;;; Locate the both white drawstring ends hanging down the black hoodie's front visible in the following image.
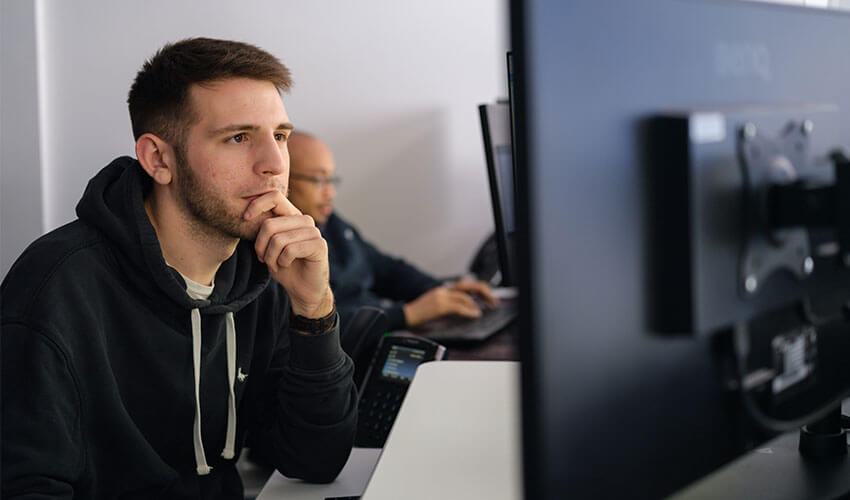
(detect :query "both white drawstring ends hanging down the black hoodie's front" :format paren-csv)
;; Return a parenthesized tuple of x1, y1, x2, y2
(192, 308, 236, 476)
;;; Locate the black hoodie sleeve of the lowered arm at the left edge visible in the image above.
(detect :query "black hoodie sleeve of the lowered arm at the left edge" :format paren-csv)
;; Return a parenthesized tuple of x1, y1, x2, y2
(0, 323, 84, 499)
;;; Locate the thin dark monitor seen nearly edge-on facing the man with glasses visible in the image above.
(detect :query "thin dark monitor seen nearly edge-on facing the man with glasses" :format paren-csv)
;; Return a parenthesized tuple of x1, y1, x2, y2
(478, 102, 516, 286)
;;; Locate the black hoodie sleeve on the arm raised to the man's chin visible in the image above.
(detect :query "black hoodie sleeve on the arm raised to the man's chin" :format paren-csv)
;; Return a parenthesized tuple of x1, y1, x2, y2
(253, 310, 357, 483)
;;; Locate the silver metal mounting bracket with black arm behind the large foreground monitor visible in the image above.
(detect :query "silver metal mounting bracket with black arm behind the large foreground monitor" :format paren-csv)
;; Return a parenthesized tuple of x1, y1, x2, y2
(738, 120, 850, 297)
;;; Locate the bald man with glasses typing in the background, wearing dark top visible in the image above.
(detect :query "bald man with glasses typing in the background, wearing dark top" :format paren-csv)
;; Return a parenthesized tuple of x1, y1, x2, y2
(288, 132, 498, 330)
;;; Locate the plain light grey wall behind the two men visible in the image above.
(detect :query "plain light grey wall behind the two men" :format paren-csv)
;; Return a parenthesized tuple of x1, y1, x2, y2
(0, 0, 508, 275)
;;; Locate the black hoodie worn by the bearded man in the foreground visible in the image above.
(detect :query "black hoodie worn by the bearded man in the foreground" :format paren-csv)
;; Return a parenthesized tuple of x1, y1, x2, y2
(0, 157, 356, 499)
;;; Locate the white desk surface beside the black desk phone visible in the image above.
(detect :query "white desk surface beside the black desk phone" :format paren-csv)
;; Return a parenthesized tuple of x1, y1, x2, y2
(253, 361, 522, 500)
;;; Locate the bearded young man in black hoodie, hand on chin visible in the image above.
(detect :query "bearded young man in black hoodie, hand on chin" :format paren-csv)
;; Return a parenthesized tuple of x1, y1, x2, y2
(0, 38, 356, 499)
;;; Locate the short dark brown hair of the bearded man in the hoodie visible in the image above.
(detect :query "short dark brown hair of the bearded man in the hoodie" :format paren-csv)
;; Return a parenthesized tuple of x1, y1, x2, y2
(127, 38, 292, 148)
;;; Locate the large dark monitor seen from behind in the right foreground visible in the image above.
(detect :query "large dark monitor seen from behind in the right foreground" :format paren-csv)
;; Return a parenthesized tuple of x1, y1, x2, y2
(511, 0, 850, 499)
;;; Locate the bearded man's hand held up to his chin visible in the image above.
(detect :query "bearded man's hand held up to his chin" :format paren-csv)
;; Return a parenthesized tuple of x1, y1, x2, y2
(244, 190, 334, 319)
